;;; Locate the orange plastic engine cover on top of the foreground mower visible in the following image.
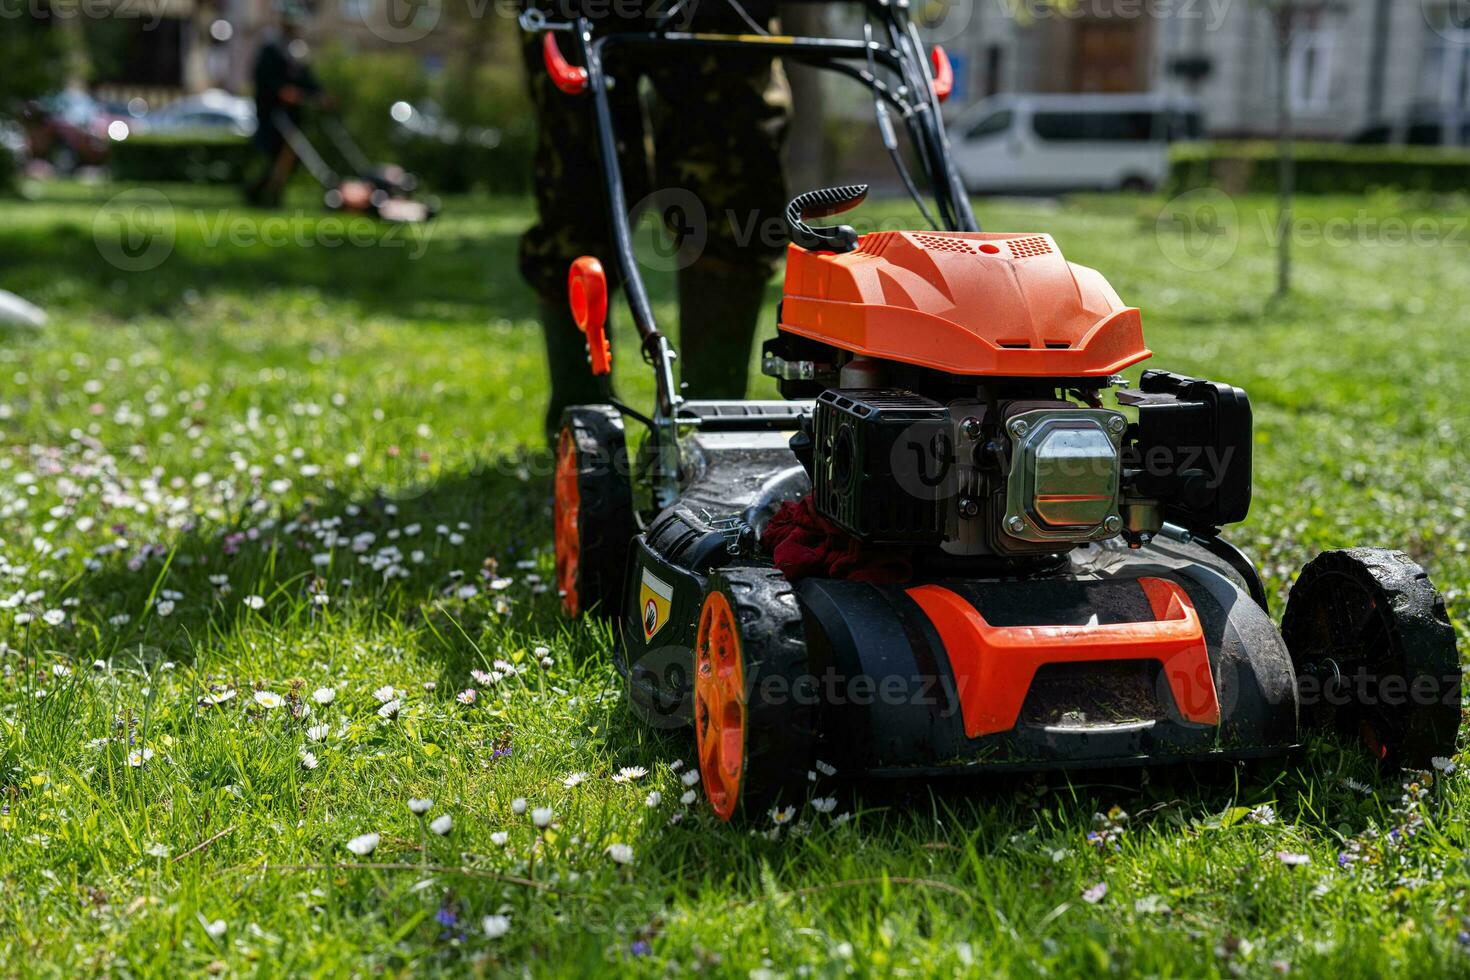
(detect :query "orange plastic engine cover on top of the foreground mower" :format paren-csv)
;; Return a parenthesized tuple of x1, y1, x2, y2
(781, 231, 1151, 378)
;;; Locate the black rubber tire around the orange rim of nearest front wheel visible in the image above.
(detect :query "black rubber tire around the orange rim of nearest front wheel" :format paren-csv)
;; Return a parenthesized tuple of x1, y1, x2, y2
(695, 566, 819, 826)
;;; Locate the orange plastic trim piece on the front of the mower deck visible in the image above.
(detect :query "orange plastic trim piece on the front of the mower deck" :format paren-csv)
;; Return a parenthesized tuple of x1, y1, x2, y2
(908, 579, 1220, 739)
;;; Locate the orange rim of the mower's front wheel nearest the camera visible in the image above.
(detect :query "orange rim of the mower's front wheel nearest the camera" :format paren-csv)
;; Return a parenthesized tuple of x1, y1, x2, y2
(694, 592, 745, 820)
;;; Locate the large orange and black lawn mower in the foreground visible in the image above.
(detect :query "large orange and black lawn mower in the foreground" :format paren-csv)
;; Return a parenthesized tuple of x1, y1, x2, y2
(522, 0, 1461, 820)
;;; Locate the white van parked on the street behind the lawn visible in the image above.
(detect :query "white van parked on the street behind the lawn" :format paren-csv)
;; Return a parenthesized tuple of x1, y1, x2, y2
(948, 94, 1202, 194)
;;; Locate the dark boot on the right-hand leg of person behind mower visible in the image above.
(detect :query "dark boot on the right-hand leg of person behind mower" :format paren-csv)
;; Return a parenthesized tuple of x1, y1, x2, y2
(679, 263, 767, 400)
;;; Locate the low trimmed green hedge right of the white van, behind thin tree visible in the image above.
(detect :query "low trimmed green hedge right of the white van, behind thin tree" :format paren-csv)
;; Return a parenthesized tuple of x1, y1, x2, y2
(1169, 141, 1470, 194)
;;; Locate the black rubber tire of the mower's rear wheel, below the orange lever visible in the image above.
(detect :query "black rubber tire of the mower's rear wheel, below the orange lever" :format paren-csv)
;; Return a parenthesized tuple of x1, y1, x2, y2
(557, 406, 638, 621)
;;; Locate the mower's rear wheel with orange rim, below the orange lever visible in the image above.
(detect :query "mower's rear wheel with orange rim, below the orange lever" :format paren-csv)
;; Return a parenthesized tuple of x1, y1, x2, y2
(554, 406, 637, 620)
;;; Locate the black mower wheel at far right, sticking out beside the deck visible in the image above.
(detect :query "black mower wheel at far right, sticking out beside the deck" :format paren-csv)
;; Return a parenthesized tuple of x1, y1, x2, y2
(1282, 548, 1461, 770)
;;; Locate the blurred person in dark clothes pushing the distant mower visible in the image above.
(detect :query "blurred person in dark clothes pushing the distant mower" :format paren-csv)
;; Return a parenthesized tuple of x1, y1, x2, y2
(245, 4, 322, 207)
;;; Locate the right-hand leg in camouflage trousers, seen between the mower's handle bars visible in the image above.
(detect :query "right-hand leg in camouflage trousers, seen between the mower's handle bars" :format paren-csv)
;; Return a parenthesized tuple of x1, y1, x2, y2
(650, 7, 791, 398)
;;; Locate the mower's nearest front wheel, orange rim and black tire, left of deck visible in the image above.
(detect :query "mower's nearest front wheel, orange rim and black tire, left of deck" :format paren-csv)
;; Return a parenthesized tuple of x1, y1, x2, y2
(694, 567, 817, 820)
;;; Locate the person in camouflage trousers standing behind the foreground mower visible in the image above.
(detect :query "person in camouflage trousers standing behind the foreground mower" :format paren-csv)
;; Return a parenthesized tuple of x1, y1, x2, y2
(520, 0, 791, 444)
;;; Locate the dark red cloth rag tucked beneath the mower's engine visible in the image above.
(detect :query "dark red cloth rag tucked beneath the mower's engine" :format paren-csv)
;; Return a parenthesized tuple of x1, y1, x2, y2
(760, 494, 913, 585)
